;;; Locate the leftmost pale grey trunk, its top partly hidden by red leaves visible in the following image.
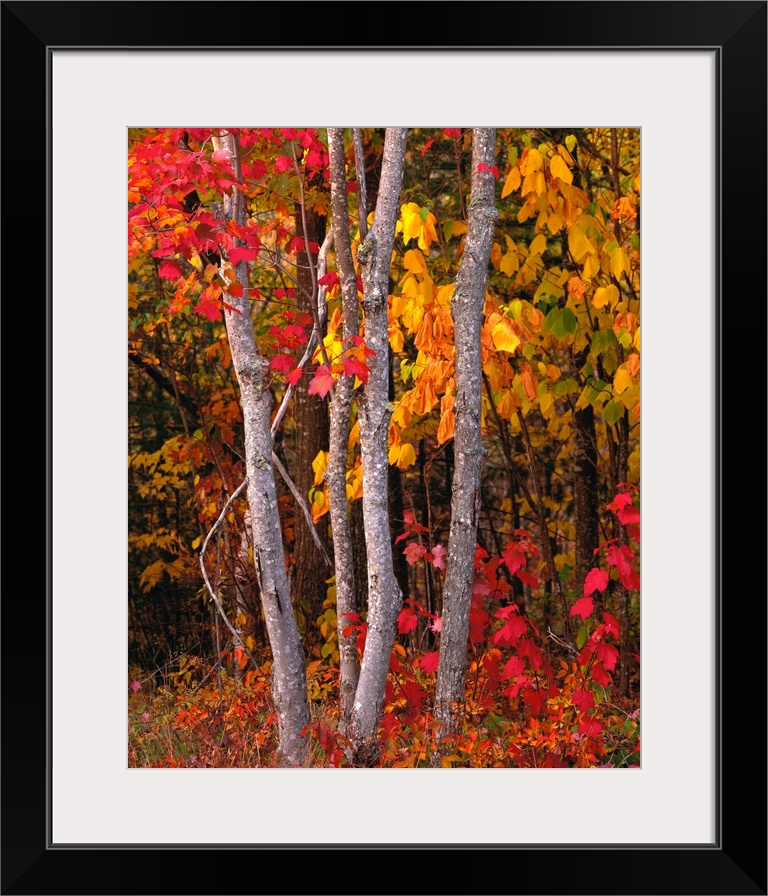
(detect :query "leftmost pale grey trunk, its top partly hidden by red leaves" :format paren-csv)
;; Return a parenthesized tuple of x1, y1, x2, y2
(215, 131, 310, 766)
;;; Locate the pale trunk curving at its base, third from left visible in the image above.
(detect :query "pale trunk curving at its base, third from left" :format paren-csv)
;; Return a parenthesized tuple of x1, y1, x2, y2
(350, 128, 407, 764)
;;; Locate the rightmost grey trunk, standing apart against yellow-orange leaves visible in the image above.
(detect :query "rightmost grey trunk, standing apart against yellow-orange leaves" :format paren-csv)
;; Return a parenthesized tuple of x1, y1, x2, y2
(435, 128, 497, 735)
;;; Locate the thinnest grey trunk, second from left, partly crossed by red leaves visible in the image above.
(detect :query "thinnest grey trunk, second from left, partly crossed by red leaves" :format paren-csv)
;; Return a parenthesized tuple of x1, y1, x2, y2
(326, 128, 360, 734)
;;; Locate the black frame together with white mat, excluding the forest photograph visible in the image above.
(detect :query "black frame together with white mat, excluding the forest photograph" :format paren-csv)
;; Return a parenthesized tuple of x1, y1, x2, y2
(2, 2, 767, 894)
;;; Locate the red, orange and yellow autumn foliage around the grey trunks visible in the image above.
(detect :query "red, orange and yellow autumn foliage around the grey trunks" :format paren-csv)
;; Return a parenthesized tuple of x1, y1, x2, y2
(128, 128, 640, 768)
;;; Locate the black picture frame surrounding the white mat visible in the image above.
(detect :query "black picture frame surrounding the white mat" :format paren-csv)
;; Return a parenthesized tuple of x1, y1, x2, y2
(0, 0, 768, 896)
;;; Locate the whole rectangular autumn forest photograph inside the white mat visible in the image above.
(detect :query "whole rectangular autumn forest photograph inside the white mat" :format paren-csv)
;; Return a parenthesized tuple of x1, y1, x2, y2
(127, 127, 641, 769)
